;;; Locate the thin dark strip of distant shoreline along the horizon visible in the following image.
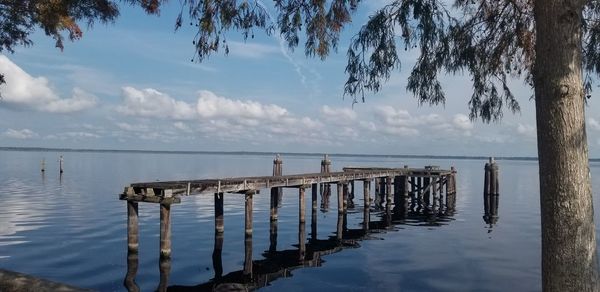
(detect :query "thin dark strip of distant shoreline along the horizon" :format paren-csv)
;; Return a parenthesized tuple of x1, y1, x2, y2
(0, 147, 600, 162)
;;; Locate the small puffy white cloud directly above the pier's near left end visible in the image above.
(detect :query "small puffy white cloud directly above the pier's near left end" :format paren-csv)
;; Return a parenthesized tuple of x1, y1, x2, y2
(117, 86, 195, 120)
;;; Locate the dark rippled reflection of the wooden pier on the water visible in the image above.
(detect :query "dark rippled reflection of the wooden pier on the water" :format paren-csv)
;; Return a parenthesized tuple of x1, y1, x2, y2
(124, 194, 454, 291)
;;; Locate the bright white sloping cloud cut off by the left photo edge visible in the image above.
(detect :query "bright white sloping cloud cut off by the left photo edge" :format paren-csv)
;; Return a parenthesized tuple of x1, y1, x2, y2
(0, 55, 97, 113)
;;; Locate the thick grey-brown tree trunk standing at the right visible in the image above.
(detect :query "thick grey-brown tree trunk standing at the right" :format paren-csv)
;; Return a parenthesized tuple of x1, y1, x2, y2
(534, 0, 599, 291)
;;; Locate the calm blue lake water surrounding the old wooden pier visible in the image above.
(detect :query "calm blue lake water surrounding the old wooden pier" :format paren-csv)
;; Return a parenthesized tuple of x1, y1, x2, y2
(0, 151, 600, 291)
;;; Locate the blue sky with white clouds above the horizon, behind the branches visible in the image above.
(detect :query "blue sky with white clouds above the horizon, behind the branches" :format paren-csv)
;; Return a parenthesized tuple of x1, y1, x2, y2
(0, 1, 600, 157)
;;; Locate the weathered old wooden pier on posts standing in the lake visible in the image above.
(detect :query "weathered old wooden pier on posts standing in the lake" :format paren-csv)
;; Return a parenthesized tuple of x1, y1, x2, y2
(119, 156, 456, 290)
